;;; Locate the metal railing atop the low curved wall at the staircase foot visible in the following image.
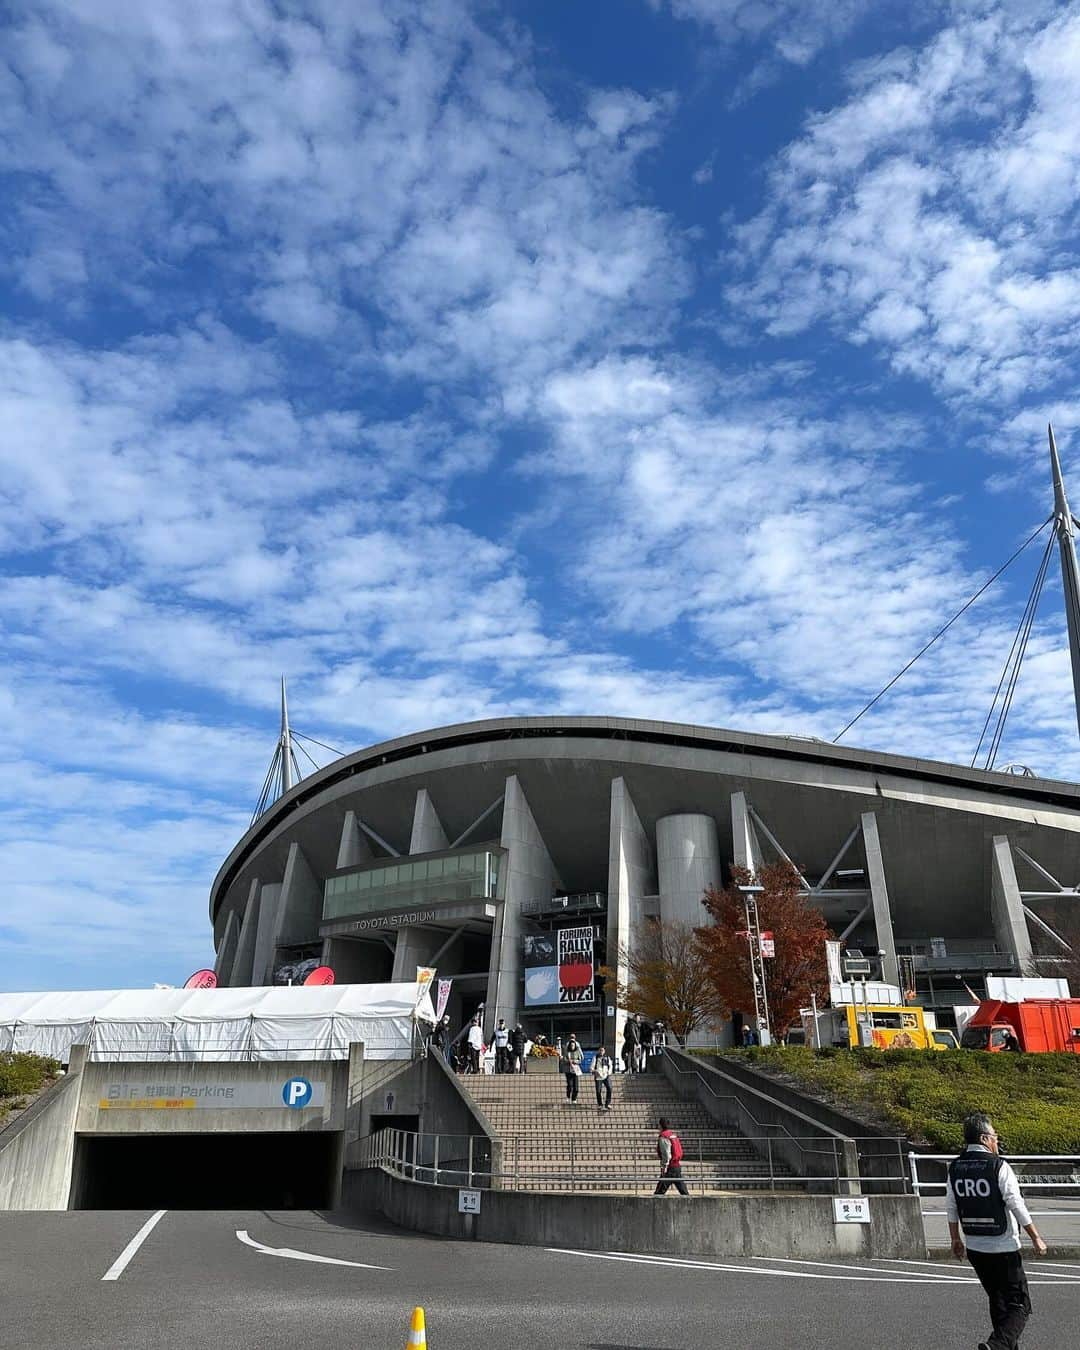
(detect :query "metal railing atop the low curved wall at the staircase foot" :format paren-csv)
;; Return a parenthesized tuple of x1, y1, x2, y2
(356, 1129, 912, 1195)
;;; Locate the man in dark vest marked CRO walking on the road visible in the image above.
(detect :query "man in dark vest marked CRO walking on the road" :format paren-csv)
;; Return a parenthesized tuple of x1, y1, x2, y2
(945, 1112, 1046, 1350)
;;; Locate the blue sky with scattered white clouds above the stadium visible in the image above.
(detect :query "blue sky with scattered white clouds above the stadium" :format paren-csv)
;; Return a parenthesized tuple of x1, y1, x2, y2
(0, 0, 1080, 988)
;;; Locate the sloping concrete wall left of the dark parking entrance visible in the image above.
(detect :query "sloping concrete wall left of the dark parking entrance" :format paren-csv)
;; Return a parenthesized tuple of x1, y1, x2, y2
(0, 1045, 86, 1210)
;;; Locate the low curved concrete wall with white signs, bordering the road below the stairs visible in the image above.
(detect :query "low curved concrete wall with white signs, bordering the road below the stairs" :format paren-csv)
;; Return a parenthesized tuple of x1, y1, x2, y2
(342, 1168, 926, 1260)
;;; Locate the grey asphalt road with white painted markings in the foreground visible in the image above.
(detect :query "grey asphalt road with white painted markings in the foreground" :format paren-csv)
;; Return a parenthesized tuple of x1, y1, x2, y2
(0, 1211, 1080, 1350)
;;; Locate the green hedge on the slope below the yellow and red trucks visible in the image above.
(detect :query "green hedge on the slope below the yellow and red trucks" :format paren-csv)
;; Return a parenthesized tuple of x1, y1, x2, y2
(725, 1045, 1080, 1153)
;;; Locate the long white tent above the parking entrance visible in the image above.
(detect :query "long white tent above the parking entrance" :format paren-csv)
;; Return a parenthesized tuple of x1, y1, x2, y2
(0, 984, 435, 1064)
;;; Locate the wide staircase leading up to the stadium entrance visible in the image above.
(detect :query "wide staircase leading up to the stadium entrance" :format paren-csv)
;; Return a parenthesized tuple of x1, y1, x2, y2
(459, 1073, 792, 1195)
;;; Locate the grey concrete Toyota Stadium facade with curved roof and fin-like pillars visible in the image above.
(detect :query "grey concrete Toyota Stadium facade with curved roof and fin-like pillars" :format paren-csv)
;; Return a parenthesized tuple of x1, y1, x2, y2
(211, 717, 1080, 1045)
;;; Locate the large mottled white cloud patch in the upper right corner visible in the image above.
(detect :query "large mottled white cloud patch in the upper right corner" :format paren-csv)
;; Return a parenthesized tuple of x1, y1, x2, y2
(729, 7, 1080, 406)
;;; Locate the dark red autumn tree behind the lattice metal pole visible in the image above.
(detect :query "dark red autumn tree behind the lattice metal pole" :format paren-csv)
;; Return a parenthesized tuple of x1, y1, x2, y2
(697, 863, 832, 1037)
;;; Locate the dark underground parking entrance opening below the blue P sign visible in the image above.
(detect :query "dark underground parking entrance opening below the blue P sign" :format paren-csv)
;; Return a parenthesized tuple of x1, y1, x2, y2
(72, 1130, 342, 1210)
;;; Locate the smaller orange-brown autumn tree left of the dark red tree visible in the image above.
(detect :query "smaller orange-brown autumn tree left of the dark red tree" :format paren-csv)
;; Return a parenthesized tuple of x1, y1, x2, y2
(599, 919, 720, 1045)
